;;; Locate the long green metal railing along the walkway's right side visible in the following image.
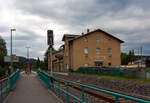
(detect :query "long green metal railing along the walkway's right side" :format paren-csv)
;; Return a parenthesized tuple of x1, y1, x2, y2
(37, 69, 150, 103)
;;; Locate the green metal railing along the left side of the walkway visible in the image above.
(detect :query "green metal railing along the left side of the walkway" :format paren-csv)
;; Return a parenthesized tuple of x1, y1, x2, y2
(0, 69, 20, 103)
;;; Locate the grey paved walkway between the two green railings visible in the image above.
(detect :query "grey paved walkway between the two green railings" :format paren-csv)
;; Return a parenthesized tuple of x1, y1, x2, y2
(6, 73, 60, 103)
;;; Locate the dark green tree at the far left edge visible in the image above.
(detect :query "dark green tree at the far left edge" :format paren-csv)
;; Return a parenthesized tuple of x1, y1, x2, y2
(0, 36, 7, 67)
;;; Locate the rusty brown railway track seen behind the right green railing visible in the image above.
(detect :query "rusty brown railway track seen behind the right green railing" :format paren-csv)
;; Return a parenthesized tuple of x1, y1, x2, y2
(52, 79, 150, 103)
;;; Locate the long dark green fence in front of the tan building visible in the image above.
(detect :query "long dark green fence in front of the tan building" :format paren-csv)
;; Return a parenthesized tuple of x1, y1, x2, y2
(76, 67, 148, 79)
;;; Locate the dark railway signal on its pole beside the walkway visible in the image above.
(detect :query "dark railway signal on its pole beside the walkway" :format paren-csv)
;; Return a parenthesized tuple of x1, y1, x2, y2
(47, 30, 54, 75)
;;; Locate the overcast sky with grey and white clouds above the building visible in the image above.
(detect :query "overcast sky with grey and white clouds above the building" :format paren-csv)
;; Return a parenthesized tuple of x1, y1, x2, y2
(0, 0, 150, 59)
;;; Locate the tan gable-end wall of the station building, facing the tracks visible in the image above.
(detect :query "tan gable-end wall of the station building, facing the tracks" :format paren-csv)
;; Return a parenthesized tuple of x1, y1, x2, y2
(72, 32, 120, 69)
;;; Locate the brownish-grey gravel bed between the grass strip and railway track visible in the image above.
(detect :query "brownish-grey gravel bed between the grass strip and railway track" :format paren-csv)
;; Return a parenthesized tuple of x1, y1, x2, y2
(55, 74, 150, 97)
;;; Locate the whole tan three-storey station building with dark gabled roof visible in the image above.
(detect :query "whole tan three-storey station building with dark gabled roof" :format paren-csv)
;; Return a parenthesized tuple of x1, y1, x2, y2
(48, 29, 123, 70)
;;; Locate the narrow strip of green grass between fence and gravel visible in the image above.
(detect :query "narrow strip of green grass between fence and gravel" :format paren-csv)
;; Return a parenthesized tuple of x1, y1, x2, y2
(73, 72, 150, 83)
